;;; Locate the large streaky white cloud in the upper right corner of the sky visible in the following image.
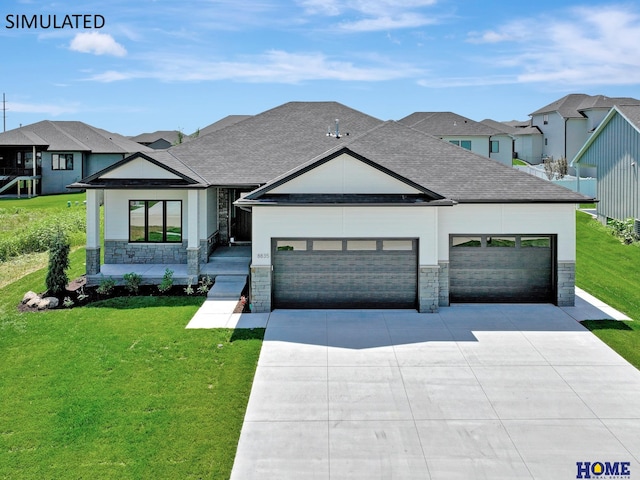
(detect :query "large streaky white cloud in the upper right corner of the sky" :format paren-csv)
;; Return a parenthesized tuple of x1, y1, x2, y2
(419, 5, 640, 88)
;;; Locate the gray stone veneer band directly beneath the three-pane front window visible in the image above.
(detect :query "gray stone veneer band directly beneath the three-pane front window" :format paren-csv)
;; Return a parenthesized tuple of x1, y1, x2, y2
(104, 240, 188, 264)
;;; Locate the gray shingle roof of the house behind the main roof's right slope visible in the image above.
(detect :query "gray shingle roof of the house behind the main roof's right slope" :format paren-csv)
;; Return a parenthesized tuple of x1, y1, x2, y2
(399, 112, 503, 137)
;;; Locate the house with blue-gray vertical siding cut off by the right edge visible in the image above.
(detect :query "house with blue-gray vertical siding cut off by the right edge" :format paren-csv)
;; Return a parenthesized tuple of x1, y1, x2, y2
(572, 105, 640, 223)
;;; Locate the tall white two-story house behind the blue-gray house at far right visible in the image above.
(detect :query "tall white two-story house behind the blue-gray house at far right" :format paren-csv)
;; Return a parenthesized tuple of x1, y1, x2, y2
(529, 93, 640, 169)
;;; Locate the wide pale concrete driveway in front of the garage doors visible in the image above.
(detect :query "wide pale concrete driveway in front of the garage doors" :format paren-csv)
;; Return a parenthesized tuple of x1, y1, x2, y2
(231, 305, 640, 480)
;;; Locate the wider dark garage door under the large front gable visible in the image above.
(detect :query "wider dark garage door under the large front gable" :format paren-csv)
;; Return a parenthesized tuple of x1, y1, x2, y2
(272, 239, 418, 308)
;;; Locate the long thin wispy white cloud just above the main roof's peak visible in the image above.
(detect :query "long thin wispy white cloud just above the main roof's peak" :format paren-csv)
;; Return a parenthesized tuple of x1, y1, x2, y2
(86, 50, 422, 84)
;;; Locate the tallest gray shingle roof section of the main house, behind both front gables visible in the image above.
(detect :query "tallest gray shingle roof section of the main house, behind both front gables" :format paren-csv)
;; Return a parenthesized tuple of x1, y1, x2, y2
(169, 102, 382, 185)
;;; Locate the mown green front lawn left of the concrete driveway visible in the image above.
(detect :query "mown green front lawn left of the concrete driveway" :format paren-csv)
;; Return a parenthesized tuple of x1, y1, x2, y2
(0, 249, 264, 479)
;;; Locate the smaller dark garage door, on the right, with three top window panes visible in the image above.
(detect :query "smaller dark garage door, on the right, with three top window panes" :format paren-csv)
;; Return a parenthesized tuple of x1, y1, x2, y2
(449, 235, 555, 303)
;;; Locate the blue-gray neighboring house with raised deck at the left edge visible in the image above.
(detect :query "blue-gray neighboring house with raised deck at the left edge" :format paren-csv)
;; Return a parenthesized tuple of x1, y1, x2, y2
(0, 120, 152, 195)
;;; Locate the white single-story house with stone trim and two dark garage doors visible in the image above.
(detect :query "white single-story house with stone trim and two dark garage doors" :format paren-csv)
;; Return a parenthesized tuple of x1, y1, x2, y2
(71, 102, 593, 312)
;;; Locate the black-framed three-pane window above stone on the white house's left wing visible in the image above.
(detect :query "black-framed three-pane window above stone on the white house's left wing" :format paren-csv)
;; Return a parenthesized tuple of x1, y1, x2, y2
(129, 200, 182, 243)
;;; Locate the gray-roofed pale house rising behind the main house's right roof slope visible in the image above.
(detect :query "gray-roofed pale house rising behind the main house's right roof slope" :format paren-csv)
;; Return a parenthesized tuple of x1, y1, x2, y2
(399, 112, 513, 166)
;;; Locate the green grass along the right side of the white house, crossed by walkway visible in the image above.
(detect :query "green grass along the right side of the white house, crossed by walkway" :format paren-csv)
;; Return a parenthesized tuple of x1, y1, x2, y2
(576, 212, 640, 368)
